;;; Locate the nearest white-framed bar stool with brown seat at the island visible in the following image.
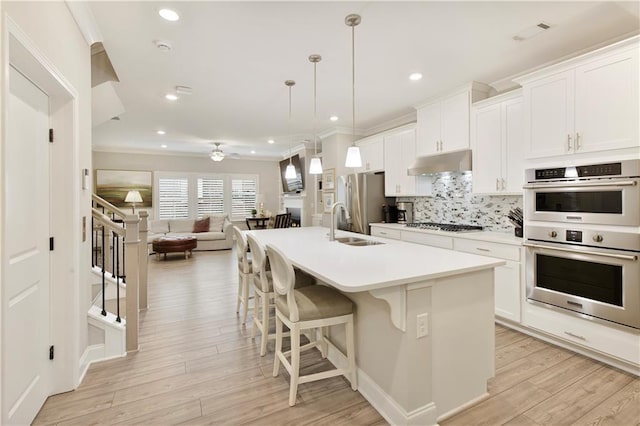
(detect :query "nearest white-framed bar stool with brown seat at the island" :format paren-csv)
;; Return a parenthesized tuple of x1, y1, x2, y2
(266, 244, 358, 407)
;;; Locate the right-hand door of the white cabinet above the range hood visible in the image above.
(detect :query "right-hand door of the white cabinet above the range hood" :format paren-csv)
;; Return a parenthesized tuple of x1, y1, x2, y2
(440, 91, 470, 152)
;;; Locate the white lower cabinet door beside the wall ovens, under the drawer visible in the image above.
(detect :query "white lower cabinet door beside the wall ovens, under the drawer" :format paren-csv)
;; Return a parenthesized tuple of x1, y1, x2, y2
(494, 261, 520, 323)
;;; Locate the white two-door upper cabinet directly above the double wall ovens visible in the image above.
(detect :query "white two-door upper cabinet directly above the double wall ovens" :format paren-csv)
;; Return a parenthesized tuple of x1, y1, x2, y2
(515, 37, 640, 159)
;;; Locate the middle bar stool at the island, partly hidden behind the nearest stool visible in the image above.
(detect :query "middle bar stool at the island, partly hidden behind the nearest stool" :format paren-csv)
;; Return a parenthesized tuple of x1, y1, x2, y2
(247, 234, 316, 356)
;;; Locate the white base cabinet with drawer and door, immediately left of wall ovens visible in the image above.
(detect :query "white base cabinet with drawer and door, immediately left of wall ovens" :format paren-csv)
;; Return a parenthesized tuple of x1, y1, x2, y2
(453, 238, 523, 323)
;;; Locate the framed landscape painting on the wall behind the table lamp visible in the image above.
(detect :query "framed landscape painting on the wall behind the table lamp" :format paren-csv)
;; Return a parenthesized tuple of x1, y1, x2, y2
(95, 170, 153, 207)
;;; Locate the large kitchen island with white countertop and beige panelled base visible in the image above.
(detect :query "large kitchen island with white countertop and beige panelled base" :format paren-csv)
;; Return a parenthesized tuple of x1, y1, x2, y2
(248, 227, 504, 425)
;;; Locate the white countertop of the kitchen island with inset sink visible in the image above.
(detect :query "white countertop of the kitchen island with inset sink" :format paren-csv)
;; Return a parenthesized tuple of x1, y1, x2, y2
(248, 227, 505, 293)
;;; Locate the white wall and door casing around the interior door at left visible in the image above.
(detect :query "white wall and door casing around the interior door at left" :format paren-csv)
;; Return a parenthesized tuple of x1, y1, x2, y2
(0, 0, 91, 402)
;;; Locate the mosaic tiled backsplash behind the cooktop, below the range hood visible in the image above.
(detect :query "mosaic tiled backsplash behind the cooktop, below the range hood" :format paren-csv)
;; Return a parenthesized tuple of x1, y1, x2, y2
(398, 172, 522, 232)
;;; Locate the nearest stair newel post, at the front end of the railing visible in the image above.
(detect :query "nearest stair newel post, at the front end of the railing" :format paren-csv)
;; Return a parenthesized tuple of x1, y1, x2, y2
(124, 215, 141, 352)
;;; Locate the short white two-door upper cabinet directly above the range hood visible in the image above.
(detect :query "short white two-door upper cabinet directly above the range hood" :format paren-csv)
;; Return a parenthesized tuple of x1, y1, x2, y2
(416, 82, 489, 156)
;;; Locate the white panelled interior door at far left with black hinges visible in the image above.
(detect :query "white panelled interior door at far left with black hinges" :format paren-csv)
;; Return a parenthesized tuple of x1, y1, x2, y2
(0, 67, 51, 424)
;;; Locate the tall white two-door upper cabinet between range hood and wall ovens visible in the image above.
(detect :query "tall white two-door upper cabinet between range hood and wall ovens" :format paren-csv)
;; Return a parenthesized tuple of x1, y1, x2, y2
(471, 90, 524, 194)
